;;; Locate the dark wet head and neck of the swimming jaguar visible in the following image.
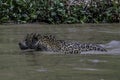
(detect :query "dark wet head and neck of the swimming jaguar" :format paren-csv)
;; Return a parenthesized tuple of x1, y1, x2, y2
(19, 33, 55, 51)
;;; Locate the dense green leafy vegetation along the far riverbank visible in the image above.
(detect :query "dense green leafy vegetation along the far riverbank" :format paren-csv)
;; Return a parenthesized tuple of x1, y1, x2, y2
(0, 0, 120, 24)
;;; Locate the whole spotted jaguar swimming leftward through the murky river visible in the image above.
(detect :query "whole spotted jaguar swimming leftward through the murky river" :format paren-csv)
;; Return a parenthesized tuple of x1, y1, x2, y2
(19, 33, 107, 54)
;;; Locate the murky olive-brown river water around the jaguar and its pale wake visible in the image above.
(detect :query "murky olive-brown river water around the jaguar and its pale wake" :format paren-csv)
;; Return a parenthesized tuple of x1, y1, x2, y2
(0, 24, 120, 80)
